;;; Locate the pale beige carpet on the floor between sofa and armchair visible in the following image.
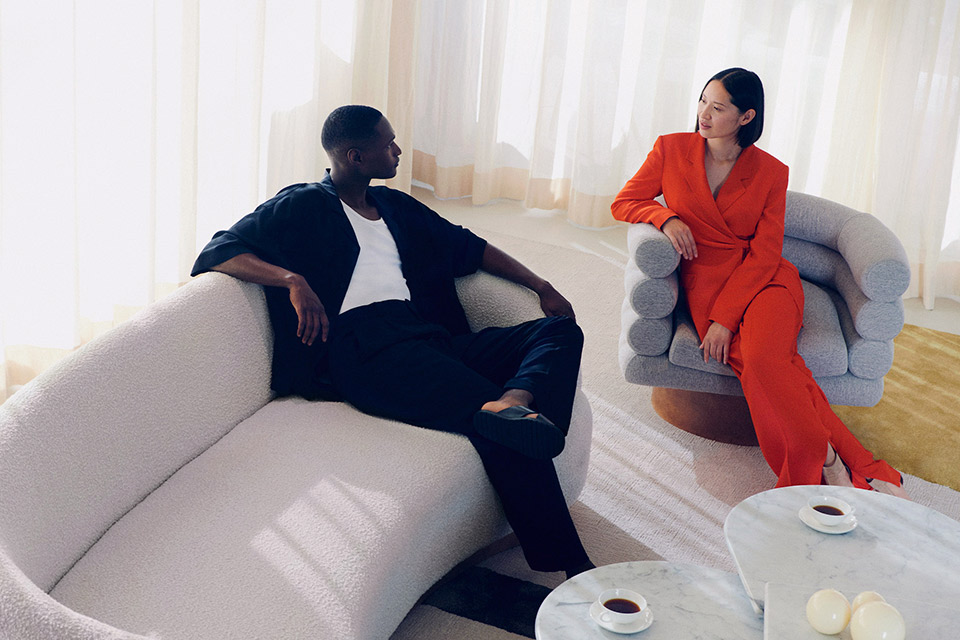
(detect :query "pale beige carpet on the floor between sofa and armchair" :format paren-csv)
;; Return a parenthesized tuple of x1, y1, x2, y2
(393, 232, 960, 640)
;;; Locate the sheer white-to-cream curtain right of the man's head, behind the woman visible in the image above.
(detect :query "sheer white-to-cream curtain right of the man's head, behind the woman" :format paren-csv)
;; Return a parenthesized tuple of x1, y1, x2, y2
(414, 0, 960, 298)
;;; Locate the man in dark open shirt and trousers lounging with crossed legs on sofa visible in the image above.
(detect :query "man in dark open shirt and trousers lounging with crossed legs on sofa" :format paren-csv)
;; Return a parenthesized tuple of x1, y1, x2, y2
(193, 105, 593, 576)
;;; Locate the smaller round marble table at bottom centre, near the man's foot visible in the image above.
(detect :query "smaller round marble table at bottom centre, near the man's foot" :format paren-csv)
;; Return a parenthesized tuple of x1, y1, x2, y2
(534, 562, 763, 640)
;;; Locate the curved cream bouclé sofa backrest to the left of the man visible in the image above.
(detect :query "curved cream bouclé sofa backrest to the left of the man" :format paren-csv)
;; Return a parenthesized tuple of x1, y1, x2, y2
(0, 274, 272, 592)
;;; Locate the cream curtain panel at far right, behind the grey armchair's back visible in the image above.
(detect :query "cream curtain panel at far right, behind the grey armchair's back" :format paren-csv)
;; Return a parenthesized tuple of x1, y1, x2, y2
(824, 0, 960, 309)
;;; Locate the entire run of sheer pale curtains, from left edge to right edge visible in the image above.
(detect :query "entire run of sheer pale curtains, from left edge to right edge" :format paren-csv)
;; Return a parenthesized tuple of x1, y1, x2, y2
(0, 0, 960, 399)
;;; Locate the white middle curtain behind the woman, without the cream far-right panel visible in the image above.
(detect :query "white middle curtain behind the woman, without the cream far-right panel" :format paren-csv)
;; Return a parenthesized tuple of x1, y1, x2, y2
(415, 0, 850, 226)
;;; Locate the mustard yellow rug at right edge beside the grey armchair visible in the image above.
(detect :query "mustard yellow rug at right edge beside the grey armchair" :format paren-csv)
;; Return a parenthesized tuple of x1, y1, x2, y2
(833, 324, 960, 491)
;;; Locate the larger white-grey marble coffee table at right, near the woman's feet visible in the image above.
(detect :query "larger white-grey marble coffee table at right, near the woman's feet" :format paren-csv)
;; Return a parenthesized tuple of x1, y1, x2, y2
(723, 486, 960, 612)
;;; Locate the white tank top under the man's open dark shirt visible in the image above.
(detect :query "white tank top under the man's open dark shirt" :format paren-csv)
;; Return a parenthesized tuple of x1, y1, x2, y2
(340, 200, 410, 313)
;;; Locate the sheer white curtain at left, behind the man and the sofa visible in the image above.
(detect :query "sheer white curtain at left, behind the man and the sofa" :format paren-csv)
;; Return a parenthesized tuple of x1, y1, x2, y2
(0, 0, 416, 400)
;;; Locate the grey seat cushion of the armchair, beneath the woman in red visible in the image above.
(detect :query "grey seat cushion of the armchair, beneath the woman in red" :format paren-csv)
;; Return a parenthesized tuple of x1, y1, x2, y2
(669, 280, 848, 378)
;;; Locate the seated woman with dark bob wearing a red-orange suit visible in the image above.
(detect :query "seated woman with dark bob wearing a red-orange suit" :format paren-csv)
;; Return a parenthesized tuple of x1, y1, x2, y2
(612, 69, 906, 497)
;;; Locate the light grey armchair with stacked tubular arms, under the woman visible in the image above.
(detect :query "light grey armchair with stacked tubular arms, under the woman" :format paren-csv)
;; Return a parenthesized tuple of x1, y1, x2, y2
(620, 191, 910, 440)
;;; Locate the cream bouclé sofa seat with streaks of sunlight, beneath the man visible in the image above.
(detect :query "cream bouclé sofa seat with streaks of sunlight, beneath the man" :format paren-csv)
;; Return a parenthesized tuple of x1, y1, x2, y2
(51, 394, 590, 640)
